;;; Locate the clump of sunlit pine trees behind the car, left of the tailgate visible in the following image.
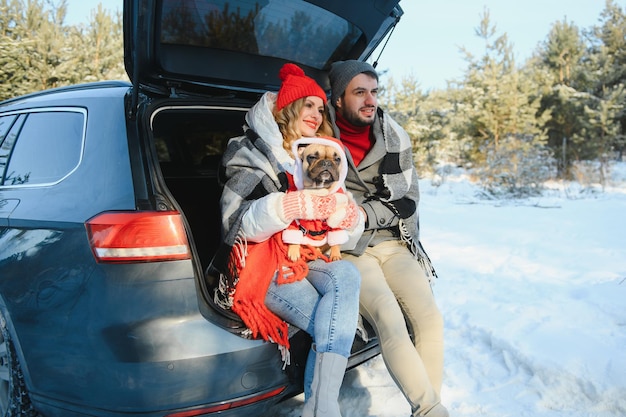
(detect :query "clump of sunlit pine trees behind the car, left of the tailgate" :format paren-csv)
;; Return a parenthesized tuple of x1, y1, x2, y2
(0, 0, 127, 99)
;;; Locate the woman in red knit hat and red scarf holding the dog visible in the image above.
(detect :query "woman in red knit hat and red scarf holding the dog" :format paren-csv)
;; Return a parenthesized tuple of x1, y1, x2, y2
(220, 64, 364, 417)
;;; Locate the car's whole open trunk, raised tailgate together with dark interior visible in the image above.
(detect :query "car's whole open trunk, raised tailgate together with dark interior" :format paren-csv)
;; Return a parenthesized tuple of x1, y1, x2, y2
(130, 0, 402, 386)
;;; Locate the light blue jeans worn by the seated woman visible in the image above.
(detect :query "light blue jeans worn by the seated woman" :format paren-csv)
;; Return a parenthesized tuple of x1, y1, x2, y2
(265, 260, 361, 395)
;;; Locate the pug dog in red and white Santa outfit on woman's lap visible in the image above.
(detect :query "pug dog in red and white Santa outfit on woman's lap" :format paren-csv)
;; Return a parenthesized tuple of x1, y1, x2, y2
(283, 137, 348, 261)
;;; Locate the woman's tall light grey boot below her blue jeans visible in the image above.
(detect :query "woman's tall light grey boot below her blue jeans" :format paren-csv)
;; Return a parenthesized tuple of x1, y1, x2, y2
(302, 352, 348, 417)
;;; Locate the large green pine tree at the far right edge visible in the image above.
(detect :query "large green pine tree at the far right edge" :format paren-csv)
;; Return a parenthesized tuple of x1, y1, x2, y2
(533, 0, 626, 178)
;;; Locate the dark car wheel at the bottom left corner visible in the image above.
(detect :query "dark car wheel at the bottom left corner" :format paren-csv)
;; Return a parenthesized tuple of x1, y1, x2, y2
(0, 313, 40, 417)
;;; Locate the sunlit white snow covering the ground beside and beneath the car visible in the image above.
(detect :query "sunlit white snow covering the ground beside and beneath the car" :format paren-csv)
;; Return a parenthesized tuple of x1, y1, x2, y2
(267, 164, 626, 417)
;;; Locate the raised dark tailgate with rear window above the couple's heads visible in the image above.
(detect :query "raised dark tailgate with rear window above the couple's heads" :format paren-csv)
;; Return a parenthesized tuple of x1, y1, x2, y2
(124, 0, 403, 92)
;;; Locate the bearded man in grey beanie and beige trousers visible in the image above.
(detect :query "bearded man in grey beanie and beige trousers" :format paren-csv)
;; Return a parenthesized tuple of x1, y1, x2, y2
(329, 61, 449, 417)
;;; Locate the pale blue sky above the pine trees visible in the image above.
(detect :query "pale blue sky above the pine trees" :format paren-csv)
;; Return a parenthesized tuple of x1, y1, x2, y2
(66, 0, 608, 90)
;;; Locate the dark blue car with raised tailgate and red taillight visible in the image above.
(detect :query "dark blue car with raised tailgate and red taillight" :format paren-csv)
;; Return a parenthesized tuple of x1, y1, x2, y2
(0, 0, 402, 417)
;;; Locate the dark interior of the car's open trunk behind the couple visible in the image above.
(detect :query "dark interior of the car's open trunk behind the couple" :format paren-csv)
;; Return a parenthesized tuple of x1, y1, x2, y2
(152, 105, 380, 370)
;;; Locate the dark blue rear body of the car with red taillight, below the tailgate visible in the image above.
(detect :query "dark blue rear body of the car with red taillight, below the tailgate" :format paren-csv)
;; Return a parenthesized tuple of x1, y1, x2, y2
(0, 83, 290, 416)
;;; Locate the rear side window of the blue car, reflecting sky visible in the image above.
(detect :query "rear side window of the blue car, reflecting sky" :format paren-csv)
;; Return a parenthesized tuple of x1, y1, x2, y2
(2, 111, 84, 186)
